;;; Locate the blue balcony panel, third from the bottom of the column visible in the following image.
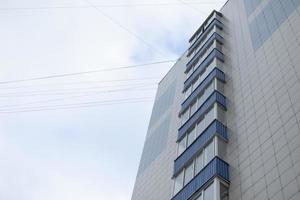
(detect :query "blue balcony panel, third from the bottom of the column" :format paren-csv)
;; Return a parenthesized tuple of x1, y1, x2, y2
(178, 91, 226, 138)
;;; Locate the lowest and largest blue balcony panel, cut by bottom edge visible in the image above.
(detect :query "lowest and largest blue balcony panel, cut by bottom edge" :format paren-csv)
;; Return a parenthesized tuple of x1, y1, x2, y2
(172, 157, 230, 200)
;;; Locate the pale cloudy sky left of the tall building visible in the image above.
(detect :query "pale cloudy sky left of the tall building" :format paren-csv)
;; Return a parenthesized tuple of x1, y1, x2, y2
(0, 0, 225, 200)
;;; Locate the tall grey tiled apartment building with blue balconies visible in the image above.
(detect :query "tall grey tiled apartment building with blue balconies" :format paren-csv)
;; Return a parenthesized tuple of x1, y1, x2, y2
(132, 0, 300, 200)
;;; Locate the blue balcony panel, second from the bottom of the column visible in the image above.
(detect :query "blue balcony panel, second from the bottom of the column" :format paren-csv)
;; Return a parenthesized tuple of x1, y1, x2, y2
(174, 120, 228, 175)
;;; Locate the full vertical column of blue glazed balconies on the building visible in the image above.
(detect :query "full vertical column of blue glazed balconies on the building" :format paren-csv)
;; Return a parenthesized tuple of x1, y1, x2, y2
(172, 11, 229, 200)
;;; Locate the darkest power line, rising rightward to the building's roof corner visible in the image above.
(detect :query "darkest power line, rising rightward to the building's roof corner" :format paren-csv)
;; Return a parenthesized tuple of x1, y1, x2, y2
(0, 60, 176, 85)
